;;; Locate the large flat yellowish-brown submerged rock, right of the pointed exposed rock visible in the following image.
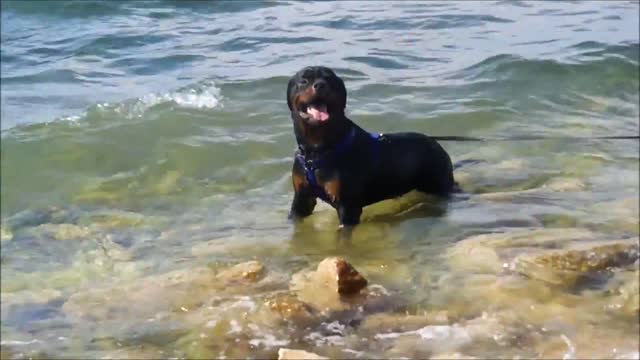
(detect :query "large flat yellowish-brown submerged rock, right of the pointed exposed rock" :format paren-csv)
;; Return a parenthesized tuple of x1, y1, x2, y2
(447, 228, 638, 286)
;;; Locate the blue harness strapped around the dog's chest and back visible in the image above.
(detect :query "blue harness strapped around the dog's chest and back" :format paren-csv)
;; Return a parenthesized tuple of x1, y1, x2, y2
(296, 128, 382, 204)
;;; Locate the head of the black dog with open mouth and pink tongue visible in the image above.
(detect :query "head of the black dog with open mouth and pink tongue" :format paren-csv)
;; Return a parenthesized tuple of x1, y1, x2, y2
(287, 66, 347, 126)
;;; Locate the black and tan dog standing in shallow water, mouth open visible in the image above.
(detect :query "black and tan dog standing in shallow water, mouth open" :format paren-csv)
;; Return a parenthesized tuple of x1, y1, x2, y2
(287, 66, 456, 233)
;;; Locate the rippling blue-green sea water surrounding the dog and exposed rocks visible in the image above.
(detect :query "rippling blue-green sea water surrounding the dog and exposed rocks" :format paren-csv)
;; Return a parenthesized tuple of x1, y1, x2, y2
(0, 0, 640, 358)
